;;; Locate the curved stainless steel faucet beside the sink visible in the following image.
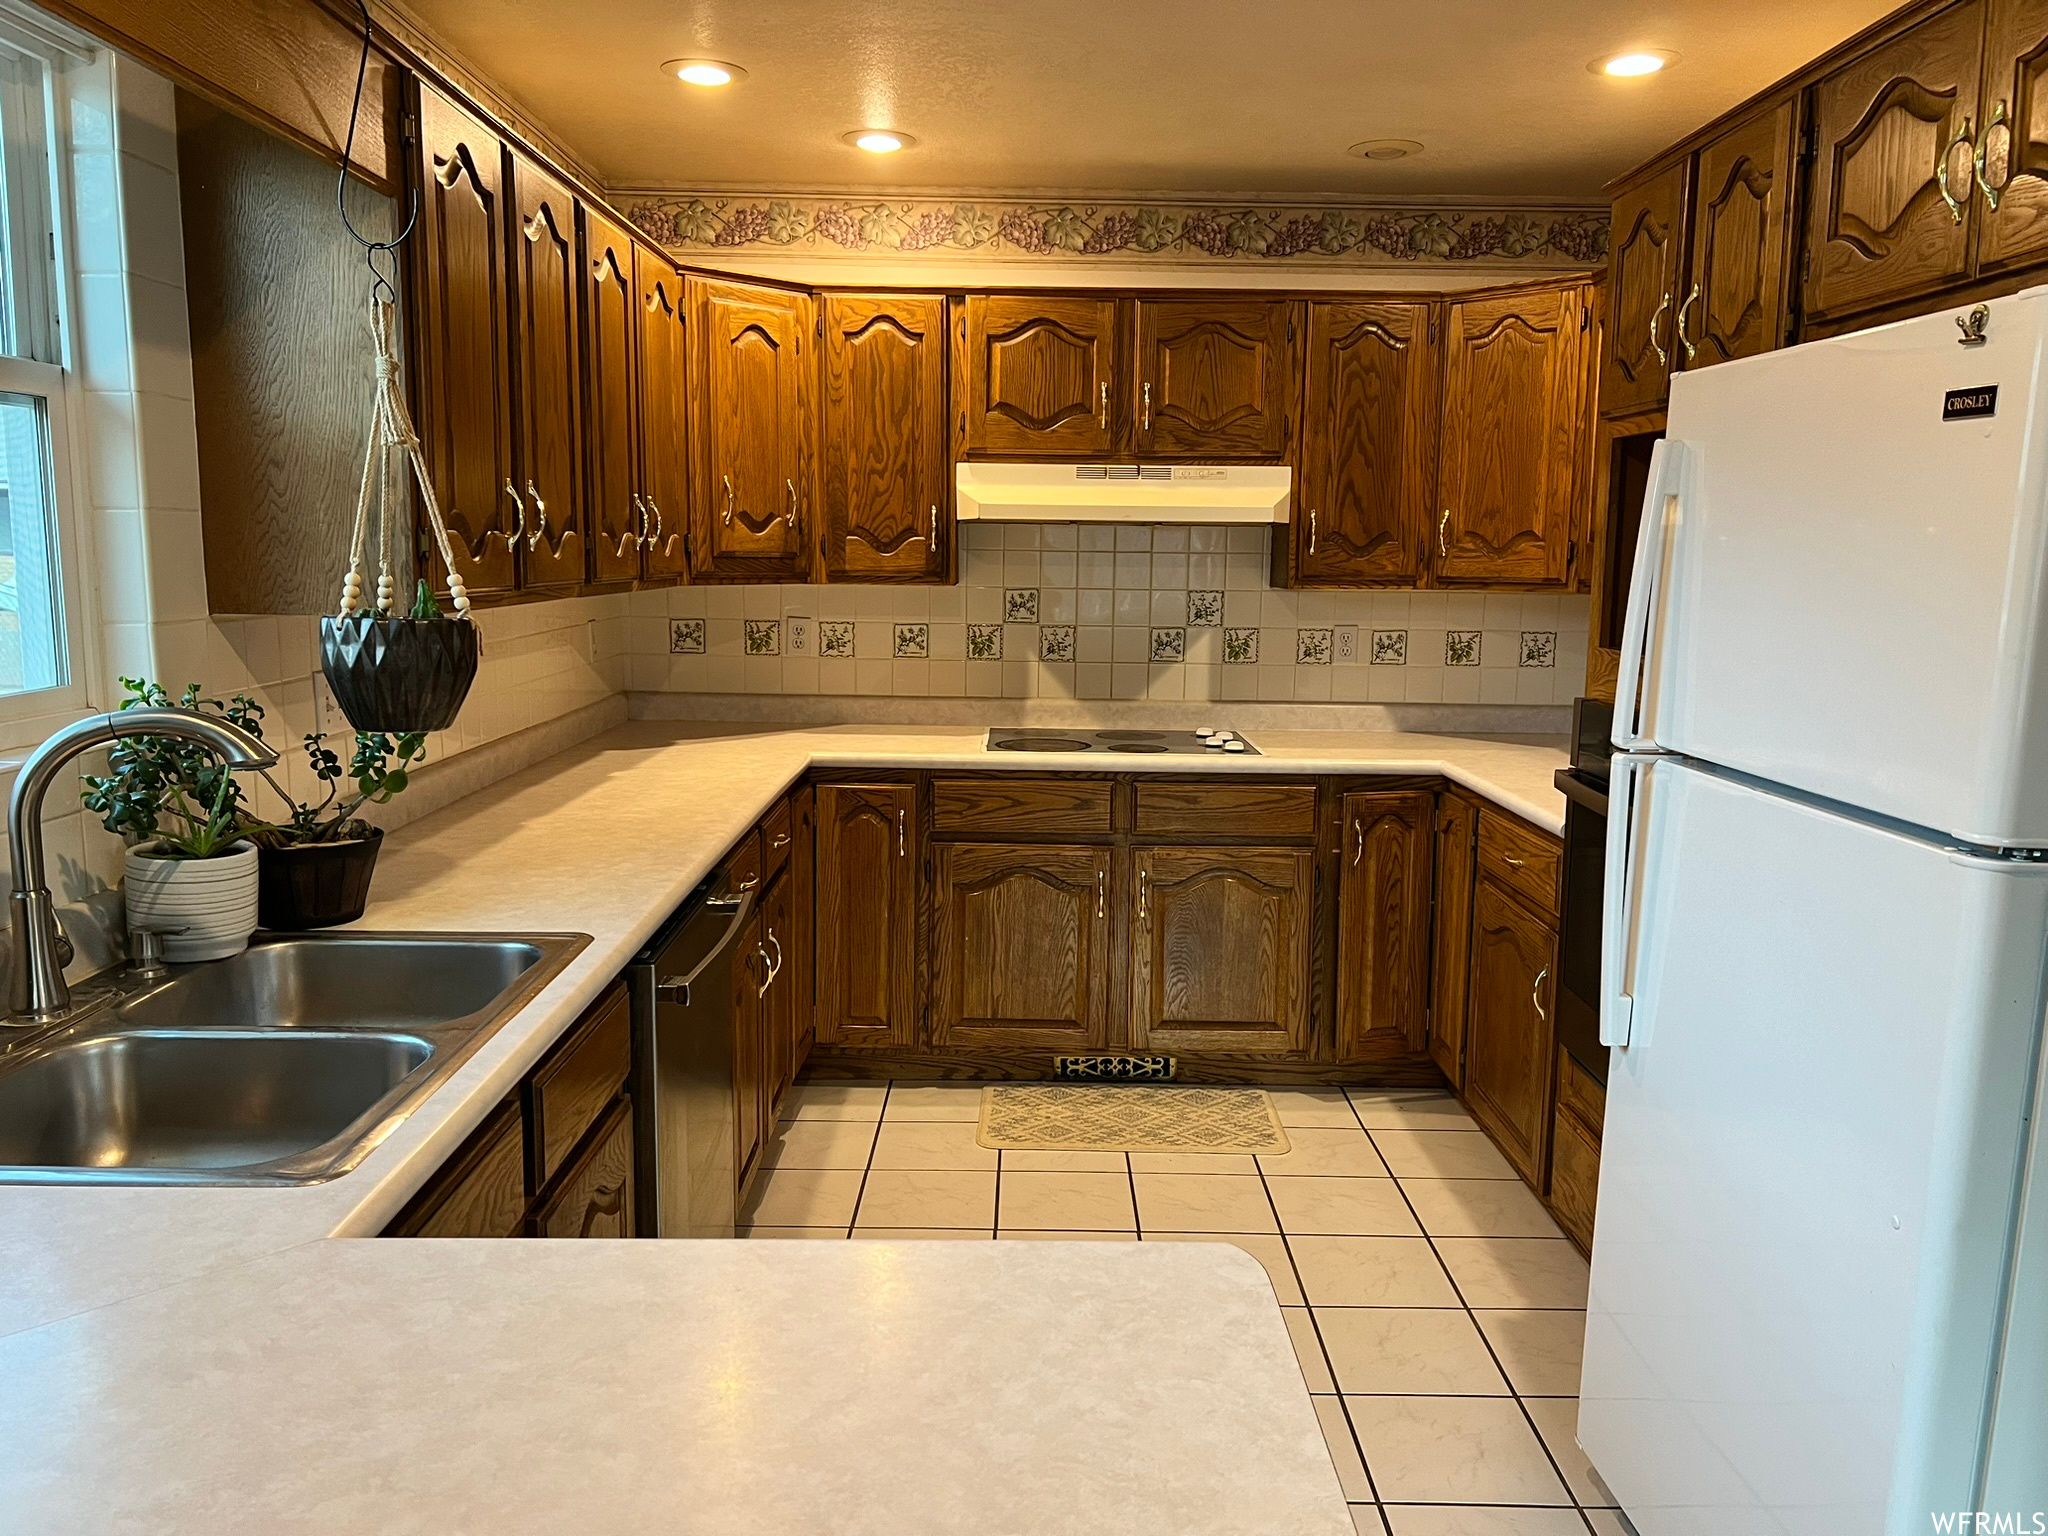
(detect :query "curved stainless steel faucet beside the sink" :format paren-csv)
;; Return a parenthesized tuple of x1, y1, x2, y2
(6, 709, 276, 1026)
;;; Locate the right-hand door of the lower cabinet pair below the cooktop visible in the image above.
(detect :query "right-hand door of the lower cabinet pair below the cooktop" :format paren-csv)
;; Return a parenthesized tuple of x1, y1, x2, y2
(1128, 848, 1315, 1053)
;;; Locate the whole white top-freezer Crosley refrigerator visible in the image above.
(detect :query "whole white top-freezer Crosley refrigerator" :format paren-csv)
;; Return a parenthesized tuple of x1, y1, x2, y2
(1579, 289, 2048, 1536)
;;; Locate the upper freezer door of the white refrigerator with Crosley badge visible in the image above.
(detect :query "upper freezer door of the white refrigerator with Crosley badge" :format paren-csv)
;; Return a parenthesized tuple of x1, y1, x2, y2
(1618, 291, 2048, 846)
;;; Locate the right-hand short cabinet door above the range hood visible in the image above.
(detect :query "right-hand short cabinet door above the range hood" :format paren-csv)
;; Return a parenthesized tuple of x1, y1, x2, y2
(1133, 299, 1300, 459)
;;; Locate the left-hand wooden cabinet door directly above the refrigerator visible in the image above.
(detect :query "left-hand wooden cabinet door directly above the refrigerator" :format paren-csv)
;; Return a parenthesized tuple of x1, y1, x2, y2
(1804, 0, 1985, 317)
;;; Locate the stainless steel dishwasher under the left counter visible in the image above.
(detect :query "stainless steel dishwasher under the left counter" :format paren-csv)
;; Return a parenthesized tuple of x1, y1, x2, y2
(627, 872, 758, 1237)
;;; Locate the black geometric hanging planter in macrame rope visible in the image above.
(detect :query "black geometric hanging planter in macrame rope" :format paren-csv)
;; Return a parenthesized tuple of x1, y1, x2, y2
(319, 612, 483, 735)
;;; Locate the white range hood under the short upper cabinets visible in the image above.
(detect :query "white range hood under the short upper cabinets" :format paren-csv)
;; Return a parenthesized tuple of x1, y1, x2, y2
(954, 463, 1294, 524)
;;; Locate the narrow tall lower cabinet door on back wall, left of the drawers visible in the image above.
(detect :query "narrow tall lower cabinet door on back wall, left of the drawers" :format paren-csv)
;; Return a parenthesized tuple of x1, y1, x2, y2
(817, 784, 918, 1047)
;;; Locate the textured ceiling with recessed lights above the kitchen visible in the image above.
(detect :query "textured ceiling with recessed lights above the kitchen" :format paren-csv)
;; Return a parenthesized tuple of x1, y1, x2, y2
(406, 0, 1892, 199)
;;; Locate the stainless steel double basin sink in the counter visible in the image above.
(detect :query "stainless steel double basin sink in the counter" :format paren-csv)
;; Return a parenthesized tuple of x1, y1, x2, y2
(0, 932, 590, 1184)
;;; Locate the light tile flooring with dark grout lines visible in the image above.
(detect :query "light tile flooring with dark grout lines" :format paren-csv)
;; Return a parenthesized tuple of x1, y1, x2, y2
(741, 1083, 1628, 1536)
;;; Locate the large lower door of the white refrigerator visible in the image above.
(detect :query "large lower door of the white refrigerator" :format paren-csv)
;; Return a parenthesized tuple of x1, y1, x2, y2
(1579, 758, 2048, 1536)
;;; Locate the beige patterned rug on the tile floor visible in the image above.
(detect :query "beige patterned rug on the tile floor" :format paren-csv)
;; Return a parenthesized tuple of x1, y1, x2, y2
(975, 1083, 1288, 1153)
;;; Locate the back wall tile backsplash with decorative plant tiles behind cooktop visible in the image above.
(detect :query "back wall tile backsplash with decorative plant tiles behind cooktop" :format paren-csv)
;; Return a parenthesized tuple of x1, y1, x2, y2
(627, 522, 1587, 707)
